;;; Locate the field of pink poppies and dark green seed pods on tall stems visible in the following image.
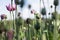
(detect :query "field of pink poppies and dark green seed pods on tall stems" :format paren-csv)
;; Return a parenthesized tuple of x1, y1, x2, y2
(0, 0, 60, 40)
